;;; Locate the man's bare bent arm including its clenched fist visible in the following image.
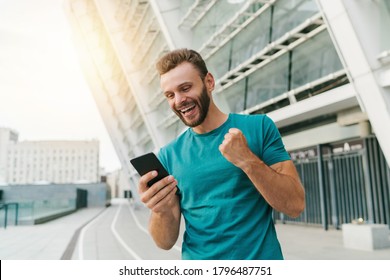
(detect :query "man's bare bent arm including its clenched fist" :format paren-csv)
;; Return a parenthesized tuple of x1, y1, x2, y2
(219, 128, 305, 218)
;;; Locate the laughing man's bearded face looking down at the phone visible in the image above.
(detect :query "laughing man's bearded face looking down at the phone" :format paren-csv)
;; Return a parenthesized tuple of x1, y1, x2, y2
(161, 62, 210, 127)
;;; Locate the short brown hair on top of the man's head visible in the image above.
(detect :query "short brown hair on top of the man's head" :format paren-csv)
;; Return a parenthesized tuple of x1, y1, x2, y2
(156, 48, 208, 80)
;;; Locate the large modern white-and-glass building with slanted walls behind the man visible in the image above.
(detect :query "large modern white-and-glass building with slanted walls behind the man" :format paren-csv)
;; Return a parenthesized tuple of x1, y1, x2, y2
(65, 0, 390, 228)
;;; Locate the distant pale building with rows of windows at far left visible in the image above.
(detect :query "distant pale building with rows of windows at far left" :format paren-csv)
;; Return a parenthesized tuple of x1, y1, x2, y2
(0, 128, 100, 185)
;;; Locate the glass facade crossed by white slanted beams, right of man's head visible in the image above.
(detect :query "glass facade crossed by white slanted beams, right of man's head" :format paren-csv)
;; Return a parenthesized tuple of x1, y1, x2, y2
(200, 0, 343, 112)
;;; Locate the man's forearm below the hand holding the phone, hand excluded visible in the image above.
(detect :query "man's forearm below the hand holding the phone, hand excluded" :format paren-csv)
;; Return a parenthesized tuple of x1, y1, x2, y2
(149, 197, 180, 250)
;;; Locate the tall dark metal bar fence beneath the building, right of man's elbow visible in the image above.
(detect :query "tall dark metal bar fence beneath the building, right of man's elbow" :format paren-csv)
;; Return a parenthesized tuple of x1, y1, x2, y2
(275, 137, 390, 230)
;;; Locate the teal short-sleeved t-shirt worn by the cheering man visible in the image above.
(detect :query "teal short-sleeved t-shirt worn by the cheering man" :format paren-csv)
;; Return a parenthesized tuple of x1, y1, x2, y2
(158, 114, 290, 260)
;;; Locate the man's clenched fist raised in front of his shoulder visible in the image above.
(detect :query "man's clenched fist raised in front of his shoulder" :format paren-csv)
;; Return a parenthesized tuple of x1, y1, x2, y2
(219, 128, 254, 168)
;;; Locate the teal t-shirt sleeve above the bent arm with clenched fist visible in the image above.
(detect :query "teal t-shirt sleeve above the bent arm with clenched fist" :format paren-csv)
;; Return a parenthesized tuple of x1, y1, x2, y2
(262, 116, 290, 166)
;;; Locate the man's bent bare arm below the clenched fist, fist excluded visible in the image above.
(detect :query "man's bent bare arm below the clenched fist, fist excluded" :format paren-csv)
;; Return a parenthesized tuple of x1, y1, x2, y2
(240, 155, 305, 217)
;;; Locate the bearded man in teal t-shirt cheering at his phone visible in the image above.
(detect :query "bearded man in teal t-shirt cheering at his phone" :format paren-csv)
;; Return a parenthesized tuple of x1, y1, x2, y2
(139, 49, 305, 259)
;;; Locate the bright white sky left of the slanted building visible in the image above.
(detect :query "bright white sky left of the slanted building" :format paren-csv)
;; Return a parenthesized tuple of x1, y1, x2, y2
(0, 0, 120, 172)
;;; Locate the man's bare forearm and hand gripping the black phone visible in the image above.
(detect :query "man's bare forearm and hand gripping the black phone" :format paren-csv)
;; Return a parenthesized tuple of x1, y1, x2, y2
(138, 171, 181, 250)
